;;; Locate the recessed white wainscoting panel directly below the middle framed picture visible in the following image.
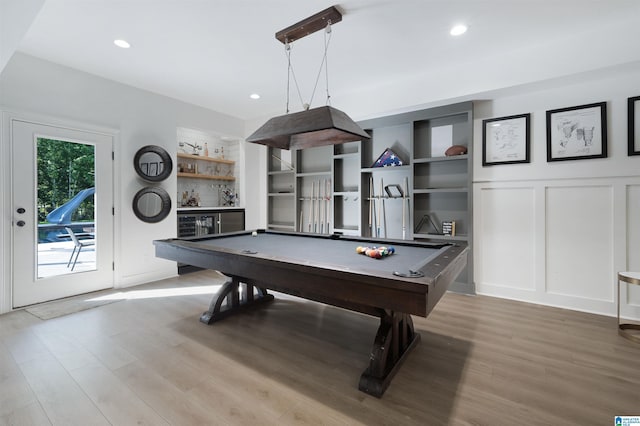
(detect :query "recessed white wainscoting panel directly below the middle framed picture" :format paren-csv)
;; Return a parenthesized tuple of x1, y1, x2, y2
(546, 185, 614, 301)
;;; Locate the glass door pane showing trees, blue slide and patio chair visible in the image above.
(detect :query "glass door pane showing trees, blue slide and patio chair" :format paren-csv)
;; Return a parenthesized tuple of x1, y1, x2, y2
(37, 138, 96, 278)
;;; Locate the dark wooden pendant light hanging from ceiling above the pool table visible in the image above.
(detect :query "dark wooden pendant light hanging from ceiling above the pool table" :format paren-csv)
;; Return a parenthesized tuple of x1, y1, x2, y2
(246, 6, 370, 149)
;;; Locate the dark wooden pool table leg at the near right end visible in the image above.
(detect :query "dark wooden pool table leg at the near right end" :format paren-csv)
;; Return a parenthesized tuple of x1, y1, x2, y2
(358, 310, 420, 398)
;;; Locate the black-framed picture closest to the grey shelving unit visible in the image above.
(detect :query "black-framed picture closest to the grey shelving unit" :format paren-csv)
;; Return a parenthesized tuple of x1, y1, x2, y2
(482, 114, 531, 166)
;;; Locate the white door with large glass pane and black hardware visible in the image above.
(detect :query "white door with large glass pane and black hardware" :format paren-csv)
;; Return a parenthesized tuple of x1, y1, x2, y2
(11, 120, 113, 308)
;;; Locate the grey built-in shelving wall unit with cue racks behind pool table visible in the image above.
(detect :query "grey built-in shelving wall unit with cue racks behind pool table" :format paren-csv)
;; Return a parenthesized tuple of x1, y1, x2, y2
(267, 102, 475, 293)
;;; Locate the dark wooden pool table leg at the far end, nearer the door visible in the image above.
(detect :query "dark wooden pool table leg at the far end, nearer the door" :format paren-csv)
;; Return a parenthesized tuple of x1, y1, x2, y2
(200, 277, 273, 324)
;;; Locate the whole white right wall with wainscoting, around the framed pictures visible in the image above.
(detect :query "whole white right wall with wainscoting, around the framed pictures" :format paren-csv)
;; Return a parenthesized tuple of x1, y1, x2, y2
(473, 60, 640, 318)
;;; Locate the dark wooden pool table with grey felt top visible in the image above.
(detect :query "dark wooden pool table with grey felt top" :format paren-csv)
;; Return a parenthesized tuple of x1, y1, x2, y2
(153, 230, 467, 397)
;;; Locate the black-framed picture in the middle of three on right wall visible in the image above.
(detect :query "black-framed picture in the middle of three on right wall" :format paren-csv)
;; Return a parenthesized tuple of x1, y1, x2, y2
(547, 102, 607, 161)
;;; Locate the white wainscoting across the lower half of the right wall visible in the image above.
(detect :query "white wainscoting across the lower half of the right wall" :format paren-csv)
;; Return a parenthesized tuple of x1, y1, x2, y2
(473, 177, 640, 321)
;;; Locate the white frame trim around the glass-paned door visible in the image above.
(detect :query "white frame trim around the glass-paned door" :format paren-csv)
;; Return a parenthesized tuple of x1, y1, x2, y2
(0, 110, 121, 314)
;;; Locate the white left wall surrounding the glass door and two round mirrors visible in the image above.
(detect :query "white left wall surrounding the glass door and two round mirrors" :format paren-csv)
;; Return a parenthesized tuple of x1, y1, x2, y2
(0, 54, 251, 312)
